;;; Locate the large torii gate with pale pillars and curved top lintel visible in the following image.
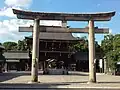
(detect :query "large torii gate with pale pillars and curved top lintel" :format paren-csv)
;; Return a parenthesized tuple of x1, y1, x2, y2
(13, 9, 115, 83)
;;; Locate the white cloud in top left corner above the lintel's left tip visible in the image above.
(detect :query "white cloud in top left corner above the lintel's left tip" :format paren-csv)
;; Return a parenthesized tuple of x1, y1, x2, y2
(0, 0, 32, 17)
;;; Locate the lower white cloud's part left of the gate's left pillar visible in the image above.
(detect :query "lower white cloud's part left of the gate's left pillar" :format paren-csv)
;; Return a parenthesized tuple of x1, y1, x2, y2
(0, 19, 32, 41)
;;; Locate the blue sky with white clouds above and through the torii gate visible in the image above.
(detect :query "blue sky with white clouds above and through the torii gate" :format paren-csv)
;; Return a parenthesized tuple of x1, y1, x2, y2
(0, 0, 120, 43)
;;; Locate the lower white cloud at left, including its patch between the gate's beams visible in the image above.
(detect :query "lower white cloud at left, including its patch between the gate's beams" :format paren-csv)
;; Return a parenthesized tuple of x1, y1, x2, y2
(0, 19, 61, 42)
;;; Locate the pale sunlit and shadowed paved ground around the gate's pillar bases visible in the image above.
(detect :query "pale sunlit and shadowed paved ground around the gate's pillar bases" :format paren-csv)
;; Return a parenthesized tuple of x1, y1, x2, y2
(0, 72, 120, 90)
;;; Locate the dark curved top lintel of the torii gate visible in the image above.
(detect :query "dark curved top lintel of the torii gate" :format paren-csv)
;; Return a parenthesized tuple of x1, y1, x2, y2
(13, 9, 115, 21)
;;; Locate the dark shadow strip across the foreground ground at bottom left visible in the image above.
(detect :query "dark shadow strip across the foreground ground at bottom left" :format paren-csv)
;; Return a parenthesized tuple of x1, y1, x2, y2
(0, 83, 70, 90)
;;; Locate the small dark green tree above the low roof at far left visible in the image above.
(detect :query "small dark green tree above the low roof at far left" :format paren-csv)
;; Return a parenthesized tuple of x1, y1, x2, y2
(3, 42, 17, 50)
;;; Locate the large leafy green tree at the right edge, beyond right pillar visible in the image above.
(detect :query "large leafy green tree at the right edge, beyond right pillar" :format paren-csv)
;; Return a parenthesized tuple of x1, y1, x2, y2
(101, 34, 120, 72)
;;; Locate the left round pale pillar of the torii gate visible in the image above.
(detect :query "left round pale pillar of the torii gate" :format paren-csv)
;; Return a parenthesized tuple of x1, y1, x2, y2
(31, 19, 39, 82)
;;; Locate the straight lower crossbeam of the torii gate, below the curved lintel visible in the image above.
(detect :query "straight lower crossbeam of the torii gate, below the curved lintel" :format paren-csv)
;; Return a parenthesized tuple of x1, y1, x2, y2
(19, 26, 109, 34)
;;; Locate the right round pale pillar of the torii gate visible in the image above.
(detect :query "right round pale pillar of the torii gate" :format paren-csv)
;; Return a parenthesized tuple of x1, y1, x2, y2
(89, 20, 96, 83)
